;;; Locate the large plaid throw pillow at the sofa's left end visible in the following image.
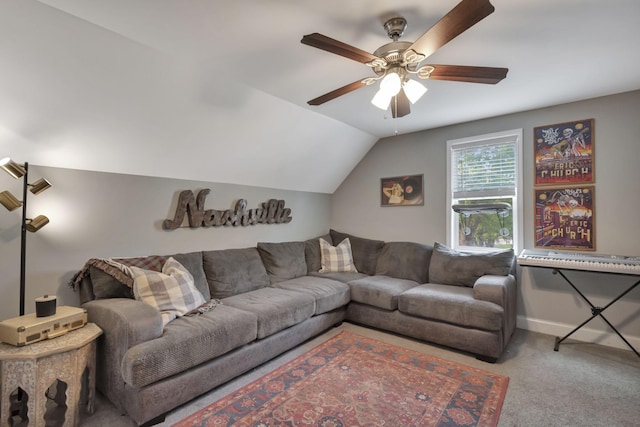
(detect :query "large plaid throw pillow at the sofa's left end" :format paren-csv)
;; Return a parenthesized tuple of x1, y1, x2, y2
(129, 258, 205, 326)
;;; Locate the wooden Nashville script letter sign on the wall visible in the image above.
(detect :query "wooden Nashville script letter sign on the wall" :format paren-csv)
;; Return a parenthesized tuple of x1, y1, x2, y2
(162, 188, 293, 230)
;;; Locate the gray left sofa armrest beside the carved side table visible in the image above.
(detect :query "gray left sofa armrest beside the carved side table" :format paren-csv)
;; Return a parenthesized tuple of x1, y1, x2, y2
(82, 298, 163, 409)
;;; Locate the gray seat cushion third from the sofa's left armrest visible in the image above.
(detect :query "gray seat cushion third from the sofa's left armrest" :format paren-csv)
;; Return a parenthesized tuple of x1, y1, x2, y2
(272, 276, 350, 314)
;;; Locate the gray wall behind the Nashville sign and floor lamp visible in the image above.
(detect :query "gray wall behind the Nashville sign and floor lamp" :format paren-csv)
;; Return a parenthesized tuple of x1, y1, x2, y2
(0, 169, 330, 319)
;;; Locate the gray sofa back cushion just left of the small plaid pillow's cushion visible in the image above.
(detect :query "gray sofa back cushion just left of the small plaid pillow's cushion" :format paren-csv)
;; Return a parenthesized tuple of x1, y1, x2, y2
(257, 242, 307, 284)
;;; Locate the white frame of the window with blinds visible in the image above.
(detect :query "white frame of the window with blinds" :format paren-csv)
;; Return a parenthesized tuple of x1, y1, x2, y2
(446, 128, 524, 253)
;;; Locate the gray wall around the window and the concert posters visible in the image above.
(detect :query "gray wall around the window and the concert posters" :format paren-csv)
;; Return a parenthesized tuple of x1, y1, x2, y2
(331, 91, 640, 349)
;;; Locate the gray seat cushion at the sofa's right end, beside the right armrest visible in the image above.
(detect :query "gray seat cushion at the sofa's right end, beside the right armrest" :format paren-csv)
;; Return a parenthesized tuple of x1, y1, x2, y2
(400, 283, 504, 331)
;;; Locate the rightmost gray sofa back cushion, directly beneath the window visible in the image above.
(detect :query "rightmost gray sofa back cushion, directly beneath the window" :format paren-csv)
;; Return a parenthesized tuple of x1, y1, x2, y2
(429, 242, 514, 287)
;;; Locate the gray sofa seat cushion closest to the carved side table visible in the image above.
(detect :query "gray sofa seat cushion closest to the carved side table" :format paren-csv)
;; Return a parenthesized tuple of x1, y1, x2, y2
(120, 305, 258, 388)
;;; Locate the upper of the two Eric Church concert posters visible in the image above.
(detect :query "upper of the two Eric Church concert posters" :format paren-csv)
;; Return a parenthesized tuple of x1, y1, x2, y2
(533, 119, 595, 185)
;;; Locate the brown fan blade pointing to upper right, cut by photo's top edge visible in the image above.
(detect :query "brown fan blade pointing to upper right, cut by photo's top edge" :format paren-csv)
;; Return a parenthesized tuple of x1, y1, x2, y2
(409, 0, 495, 57)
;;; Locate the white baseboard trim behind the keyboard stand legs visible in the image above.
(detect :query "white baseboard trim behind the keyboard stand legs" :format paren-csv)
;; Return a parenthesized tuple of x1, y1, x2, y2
(516, 316, 640, 351)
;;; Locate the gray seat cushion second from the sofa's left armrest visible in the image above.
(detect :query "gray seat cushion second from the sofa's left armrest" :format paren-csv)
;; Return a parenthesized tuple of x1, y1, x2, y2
(222, 287, 316, 339)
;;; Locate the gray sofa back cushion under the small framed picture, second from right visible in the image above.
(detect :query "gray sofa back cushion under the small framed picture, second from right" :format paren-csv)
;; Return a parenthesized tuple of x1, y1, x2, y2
(376, 242, 433, 283)
